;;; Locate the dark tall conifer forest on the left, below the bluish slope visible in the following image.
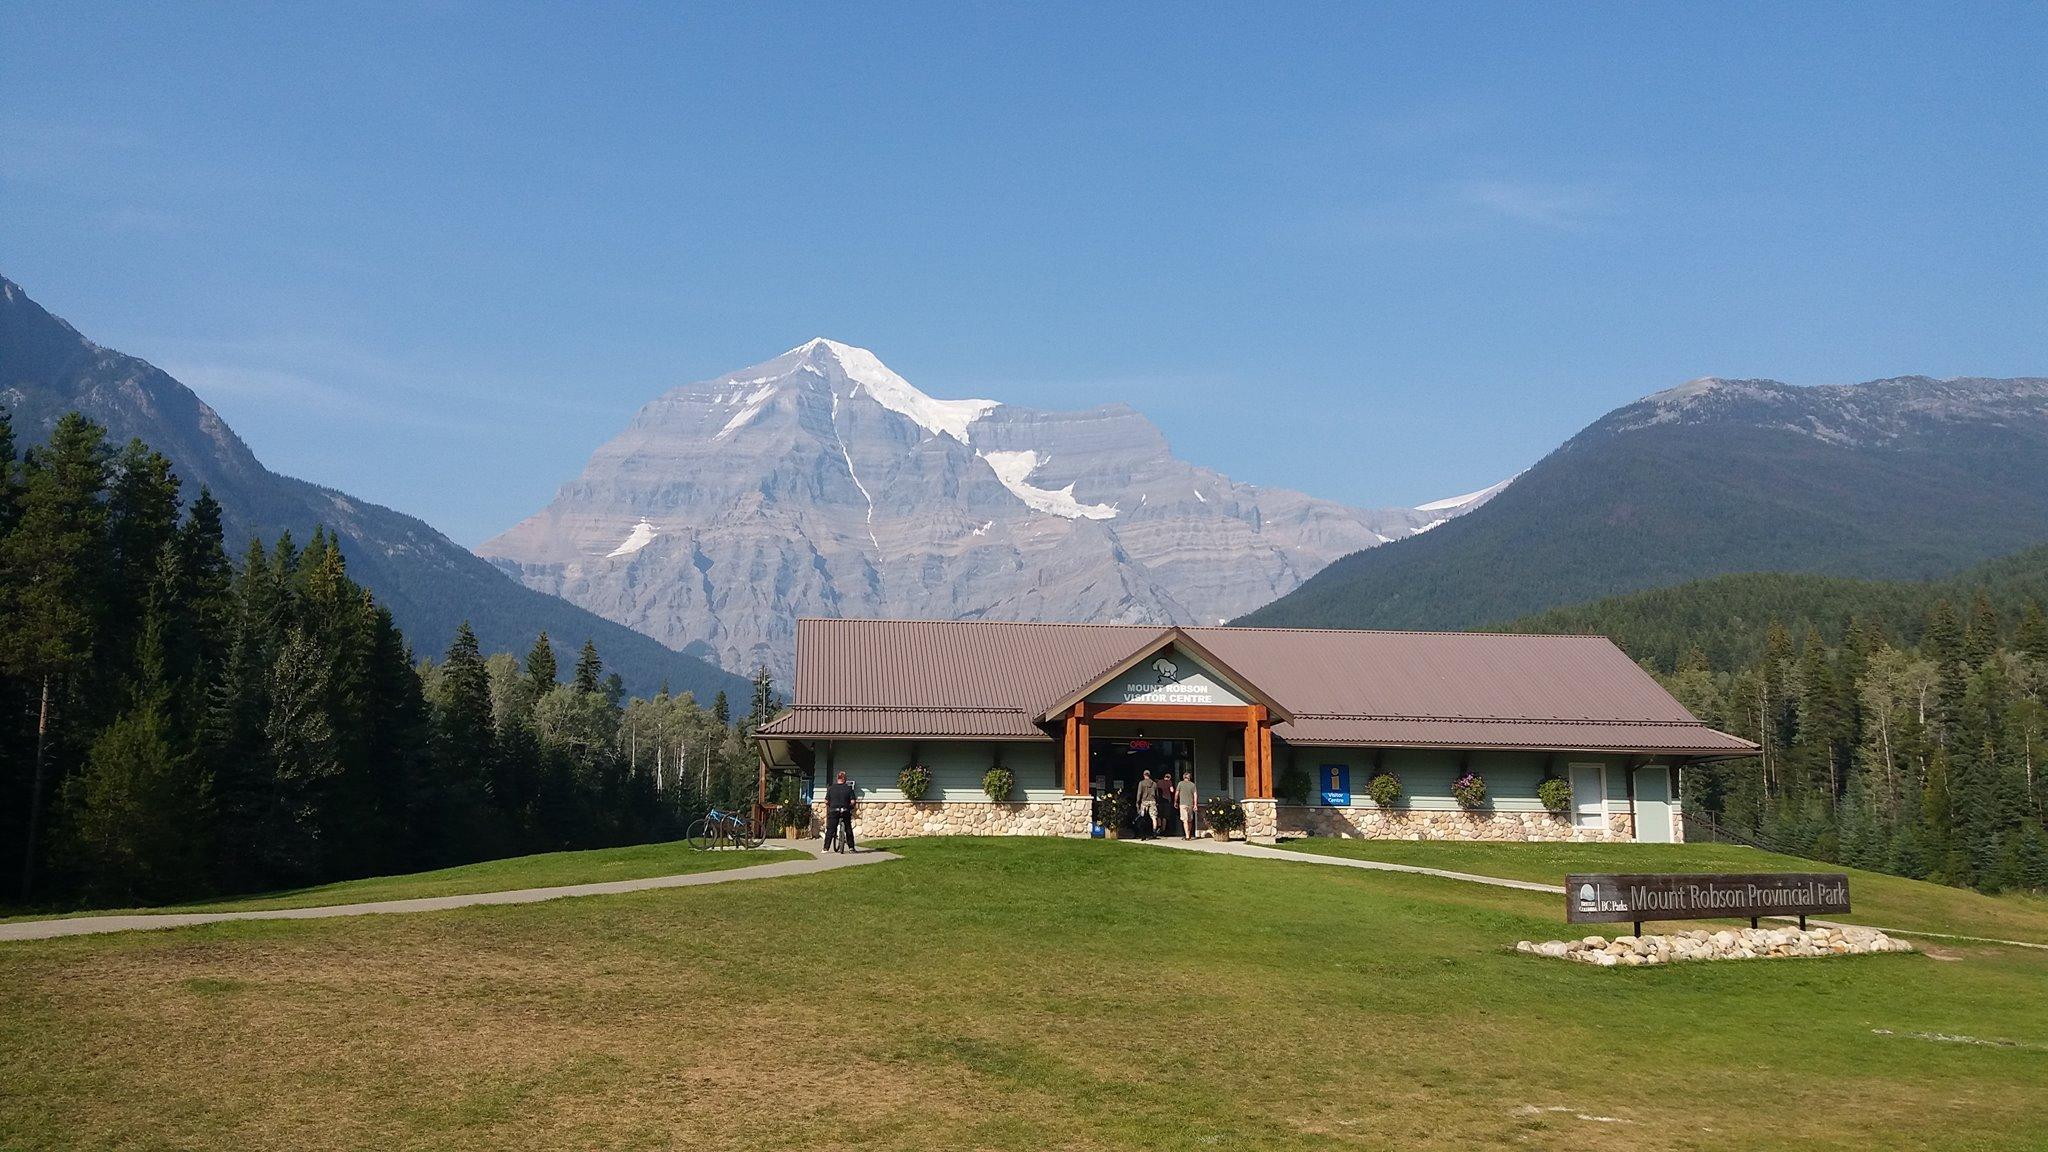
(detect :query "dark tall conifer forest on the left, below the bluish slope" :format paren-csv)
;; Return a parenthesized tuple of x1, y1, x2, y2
(0, 412, 774, 906)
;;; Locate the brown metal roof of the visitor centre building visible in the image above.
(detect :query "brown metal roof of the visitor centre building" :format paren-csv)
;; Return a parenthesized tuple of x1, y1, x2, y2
(764, 619, 1751, 754)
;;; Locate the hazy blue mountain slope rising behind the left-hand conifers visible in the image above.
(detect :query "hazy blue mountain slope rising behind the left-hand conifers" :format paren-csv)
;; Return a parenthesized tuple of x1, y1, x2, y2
(0, 277, 748, 701)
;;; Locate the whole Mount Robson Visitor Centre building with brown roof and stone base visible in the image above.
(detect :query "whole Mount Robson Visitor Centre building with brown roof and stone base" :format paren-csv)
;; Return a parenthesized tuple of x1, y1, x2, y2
(756, 619, 1755, 842)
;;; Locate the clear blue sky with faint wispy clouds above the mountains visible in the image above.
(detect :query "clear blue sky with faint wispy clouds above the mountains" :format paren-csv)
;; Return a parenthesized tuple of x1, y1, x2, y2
(0, 0, 2048, 543)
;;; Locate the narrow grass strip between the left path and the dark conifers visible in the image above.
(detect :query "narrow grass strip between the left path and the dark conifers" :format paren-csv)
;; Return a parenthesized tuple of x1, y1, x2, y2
(8, 828, 807, 920)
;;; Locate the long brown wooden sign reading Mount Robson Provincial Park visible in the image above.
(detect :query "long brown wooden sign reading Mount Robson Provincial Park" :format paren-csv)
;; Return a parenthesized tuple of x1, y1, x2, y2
(1565, 871, 1849, 935)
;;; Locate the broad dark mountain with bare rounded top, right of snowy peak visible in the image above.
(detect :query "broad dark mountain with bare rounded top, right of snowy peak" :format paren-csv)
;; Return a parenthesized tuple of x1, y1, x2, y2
(1241, 377, 2048, 627)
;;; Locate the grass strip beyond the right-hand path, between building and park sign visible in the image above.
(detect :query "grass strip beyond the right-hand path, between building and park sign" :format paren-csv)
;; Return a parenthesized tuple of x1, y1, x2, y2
(1280, 836, 2048, 945)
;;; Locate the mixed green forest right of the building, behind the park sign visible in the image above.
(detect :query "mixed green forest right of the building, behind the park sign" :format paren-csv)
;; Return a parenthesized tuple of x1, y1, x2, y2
(1613, 580, 2048, 892)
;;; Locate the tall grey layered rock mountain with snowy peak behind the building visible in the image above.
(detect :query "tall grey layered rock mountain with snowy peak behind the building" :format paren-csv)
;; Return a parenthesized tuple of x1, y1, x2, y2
(479, 340, 1499, 678)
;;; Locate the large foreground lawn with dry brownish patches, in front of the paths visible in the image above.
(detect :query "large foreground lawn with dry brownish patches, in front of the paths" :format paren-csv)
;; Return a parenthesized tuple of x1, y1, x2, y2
(0, 838, 2048, 1152)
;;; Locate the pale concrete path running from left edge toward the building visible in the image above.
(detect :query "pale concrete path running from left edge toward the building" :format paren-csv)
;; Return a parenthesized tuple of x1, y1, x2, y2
(0, 840, 901, 941)
